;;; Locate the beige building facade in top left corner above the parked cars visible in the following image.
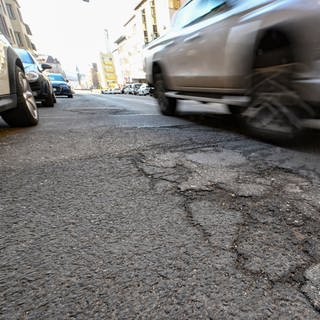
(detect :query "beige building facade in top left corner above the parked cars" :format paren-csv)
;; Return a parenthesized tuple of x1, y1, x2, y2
(0, 0, 36, 55)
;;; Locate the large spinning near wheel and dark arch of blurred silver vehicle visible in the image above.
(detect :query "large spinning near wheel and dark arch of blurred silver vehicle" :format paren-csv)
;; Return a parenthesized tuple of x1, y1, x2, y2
(242, 47, 312, 142)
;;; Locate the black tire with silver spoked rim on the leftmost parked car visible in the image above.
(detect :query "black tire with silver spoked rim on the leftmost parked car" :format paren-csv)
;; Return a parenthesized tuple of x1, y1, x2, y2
(1, 65, 39, 127)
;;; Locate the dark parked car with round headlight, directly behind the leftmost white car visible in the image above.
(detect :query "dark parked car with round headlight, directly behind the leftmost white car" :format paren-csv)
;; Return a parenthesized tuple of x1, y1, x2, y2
(15, 49, 56, 107)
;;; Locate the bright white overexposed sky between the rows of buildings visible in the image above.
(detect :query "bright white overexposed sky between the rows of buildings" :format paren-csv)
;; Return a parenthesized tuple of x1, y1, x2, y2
(18, 0, 138, 74)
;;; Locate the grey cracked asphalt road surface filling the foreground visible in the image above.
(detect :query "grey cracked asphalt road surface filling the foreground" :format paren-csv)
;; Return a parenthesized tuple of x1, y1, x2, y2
(0, 93, 320, 319)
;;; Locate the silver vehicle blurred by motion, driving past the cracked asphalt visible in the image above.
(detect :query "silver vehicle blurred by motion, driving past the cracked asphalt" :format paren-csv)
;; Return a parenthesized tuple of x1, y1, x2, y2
(144, 0, 320, 139)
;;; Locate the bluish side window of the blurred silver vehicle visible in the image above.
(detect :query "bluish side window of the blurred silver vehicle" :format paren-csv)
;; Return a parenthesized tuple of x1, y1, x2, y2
(173, 0, 227, 29)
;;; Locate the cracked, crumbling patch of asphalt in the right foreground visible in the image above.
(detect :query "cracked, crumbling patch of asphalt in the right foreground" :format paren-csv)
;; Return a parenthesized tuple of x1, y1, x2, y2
(130, 145, 320, 312)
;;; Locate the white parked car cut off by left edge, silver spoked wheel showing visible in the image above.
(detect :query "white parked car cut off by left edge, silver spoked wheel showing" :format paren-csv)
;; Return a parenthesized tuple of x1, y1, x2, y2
(0, 33, 39, 126)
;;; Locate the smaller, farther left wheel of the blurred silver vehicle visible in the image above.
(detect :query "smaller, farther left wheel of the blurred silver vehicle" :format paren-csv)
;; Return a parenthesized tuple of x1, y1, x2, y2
(154, 73, 177, 116)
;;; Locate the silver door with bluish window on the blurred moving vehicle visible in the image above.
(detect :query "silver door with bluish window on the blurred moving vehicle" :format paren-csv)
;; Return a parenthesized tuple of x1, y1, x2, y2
(162, 0, 231, 90)
